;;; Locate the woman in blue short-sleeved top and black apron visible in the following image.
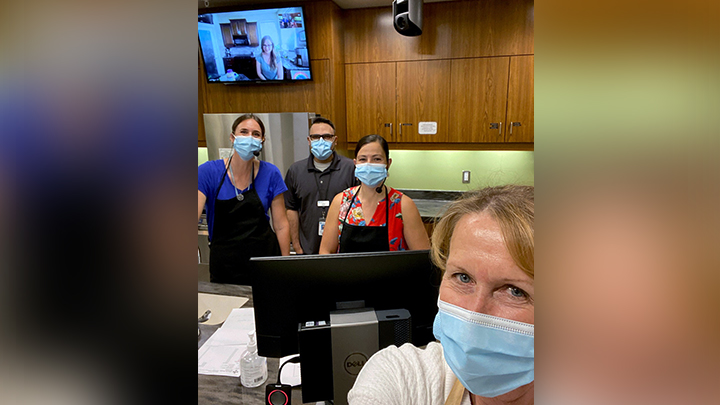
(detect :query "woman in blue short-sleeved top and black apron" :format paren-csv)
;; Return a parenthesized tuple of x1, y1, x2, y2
(198, 114, 290, 285)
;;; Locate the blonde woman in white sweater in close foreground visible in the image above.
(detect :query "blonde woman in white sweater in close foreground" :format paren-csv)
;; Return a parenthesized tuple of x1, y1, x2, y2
(348, 186, 535, 405)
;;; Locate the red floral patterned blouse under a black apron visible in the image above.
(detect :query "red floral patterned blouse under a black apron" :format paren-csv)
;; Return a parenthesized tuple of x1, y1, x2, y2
(338, 186, 408, 252)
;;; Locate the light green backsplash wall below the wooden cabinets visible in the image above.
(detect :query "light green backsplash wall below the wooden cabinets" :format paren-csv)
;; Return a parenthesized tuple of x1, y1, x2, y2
(198, 148, 535, 191)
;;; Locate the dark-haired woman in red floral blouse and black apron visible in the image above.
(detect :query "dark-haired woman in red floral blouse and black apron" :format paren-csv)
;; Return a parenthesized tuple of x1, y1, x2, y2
(320, 135, 430, 254)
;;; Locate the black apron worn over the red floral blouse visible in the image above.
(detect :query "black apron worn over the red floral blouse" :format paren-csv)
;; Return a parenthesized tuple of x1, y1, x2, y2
(340, 186, 390, 253)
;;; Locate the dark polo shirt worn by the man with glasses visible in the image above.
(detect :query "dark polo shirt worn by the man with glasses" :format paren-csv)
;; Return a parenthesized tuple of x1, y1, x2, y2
(285, 152, 356, 254)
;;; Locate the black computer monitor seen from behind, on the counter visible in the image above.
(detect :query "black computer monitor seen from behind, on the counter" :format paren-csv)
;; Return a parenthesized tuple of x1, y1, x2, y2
(250, 250, 441, 357)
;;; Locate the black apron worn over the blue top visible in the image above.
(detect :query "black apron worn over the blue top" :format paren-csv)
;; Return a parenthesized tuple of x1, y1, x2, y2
(210, 159, 281, 285)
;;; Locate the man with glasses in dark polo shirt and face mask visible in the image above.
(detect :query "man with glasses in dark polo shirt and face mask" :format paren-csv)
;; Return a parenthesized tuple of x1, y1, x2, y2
(285, 117, 357, 254)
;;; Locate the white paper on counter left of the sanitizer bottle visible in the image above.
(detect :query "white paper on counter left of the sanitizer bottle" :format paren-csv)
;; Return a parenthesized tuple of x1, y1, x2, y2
(198, 308, 258, 377)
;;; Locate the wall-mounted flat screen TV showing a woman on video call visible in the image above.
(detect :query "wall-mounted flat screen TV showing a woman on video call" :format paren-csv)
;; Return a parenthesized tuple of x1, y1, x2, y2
(198, 6, 312, 84)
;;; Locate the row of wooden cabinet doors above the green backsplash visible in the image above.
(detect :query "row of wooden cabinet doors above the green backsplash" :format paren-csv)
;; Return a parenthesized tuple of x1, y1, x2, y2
(345, 56, 534, 143)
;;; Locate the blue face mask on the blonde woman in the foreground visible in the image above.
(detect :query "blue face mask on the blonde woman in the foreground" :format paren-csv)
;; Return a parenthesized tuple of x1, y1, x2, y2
(433, 300, 535, 397)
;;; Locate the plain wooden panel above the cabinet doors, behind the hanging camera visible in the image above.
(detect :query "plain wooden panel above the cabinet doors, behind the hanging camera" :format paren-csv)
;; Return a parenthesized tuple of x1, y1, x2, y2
(344, 0, 535, 63)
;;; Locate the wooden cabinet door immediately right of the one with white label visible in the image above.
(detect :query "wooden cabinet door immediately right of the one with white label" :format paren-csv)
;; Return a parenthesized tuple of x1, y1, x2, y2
(449, 57, 509, 142)
